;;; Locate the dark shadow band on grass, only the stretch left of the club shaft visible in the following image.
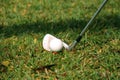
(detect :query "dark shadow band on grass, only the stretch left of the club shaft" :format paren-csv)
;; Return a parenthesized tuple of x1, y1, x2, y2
(0, 19, 86, 38)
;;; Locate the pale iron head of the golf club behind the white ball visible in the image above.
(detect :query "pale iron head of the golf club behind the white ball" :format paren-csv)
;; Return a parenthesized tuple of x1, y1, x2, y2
(42, 34, 69, 51)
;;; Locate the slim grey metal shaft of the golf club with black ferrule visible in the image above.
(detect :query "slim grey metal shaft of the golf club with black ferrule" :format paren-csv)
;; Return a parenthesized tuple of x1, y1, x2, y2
(69, 0, 108, 50)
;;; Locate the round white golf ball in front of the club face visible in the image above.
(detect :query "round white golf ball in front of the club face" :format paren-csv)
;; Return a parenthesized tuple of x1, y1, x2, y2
(50, 39, 63, 52)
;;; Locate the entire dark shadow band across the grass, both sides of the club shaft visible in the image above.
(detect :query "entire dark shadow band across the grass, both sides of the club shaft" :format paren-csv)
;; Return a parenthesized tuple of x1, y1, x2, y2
(0, 15, 120, 38)
